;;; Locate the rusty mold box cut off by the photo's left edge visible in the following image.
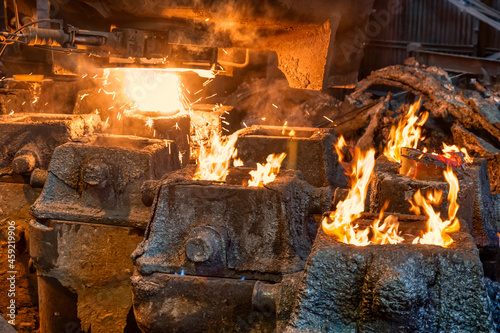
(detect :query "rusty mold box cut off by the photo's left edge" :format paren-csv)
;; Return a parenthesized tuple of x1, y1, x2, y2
(0, 113, 100, 181)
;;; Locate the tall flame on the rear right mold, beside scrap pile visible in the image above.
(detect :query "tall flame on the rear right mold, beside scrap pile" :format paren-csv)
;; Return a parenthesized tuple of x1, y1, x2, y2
(384, 98, 429, 163)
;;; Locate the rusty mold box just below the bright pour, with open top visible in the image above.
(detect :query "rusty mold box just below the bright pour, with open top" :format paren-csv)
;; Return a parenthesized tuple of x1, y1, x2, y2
(32, 135, 180, 228)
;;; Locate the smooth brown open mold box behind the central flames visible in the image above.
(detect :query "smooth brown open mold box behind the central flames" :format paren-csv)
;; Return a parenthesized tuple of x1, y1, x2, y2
(236, 125, 347, 188)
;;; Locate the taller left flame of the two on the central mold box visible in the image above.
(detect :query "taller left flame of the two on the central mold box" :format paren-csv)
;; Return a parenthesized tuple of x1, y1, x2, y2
(193, 134, 238, 182)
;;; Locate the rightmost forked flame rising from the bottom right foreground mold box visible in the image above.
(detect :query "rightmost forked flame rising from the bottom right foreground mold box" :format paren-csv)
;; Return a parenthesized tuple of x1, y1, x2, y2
(410, 167, 460, 247)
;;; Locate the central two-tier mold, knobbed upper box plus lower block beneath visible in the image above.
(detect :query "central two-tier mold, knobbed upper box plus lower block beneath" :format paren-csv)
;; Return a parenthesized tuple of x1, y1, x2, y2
(132, 166, 333, 332)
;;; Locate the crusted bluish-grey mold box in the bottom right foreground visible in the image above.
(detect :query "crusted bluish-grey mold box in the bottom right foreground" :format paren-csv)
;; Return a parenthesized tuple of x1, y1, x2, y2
(286, 228, 493, 332)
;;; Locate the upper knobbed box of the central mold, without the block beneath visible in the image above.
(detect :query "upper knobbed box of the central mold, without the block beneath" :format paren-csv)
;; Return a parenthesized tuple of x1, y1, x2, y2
(133, 166, 333, 280)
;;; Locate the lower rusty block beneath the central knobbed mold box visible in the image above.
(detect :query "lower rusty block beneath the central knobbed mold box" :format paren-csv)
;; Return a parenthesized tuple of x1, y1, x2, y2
(132, 273, 276, 333)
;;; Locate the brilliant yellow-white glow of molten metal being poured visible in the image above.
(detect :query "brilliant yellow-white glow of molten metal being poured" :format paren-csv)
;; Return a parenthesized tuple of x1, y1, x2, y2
(104, 68, 183, 115)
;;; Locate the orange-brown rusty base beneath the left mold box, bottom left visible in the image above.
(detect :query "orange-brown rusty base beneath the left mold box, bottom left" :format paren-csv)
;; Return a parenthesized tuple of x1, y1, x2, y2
(29, 221, 143, 333)
